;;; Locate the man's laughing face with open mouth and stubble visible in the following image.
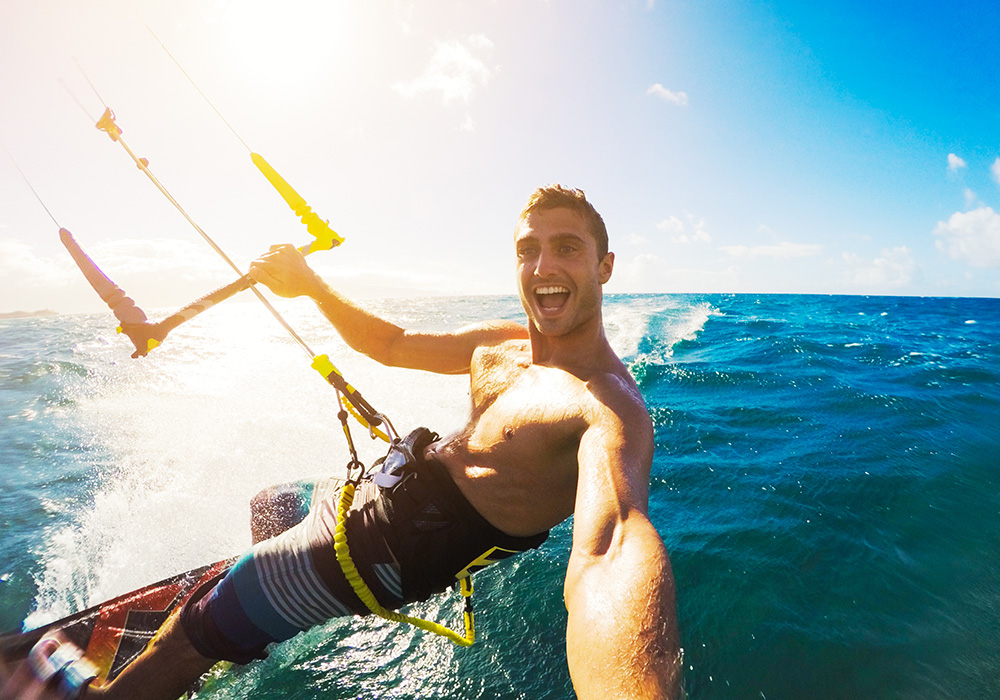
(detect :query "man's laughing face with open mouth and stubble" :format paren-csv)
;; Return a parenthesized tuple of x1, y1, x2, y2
(514, 207, 614, 336)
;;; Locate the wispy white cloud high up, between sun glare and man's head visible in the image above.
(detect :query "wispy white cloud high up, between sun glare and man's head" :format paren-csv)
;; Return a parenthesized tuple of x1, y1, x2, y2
(394, 34, 499, 104)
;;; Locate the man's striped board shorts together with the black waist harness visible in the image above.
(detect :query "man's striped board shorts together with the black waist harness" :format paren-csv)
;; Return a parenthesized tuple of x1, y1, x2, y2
(181, 461, 548, 663)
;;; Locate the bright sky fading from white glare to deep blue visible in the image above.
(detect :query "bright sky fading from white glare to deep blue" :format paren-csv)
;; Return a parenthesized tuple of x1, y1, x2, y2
(0, 0, 1000, 313)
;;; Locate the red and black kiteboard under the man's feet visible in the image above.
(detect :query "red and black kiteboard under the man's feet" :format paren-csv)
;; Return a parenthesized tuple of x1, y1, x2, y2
(0, 557, 236, 681)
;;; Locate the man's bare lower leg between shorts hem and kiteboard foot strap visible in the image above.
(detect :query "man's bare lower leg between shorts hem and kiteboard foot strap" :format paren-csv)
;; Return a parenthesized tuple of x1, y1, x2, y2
(83, 613, 217, 700)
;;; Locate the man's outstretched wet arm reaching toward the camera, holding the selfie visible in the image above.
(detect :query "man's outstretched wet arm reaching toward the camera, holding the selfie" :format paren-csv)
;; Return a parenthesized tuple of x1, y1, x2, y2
(565, 386, 681, 699)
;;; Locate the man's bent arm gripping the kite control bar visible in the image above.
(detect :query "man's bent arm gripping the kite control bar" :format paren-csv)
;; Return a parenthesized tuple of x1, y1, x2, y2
(250, 245, 528, 374)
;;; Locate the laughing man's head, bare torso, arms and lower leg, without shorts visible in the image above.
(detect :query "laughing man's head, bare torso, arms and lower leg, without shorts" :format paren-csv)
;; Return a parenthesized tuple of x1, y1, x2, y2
(0, 185, 680, 700)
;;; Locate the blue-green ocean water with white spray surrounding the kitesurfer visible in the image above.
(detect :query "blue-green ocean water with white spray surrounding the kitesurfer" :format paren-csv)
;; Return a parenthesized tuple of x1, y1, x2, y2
(0, 295, 1000, 700)
